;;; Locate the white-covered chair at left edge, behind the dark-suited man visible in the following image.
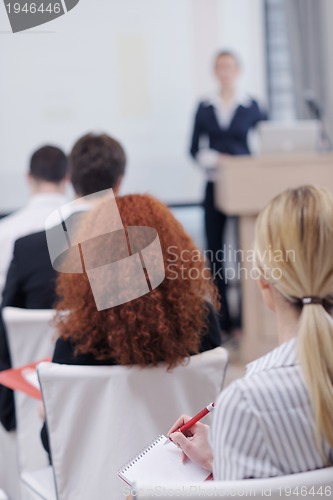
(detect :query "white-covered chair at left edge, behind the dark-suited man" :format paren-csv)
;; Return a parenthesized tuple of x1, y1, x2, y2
(2, 307, 55, 471)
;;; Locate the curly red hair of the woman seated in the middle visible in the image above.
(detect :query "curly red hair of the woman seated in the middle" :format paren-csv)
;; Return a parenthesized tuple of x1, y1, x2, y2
(56, 195, 218, 367)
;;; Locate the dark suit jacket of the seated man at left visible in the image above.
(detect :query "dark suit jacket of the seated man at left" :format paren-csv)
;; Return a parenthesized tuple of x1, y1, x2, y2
(0, 231, 56, 431)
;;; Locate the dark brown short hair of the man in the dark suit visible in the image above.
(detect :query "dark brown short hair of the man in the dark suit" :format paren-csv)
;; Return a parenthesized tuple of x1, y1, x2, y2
(69, 134, 126, 196)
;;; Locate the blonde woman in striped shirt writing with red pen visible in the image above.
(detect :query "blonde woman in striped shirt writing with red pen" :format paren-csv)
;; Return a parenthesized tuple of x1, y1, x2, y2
(169, 186, 333, 480)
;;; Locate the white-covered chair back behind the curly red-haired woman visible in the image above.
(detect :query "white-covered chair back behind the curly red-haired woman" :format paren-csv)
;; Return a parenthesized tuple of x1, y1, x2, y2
(38, 347, 228, 500)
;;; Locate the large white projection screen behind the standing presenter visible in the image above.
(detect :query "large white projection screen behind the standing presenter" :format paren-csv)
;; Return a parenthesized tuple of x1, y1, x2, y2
(0, 0, 266, 212)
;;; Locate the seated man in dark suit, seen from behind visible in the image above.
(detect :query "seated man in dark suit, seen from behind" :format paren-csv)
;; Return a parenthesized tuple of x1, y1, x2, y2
(0, 134, 126, 431)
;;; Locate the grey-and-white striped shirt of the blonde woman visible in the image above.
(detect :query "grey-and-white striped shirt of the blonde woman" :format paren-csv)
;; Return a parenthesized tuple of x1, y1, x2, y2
(210, 338, 333, 481)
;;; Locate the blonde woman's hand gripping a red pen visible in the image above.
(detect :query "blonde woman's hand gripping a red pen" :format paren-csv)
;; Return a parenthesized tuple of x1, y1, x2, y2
(168, 415, 213, 472)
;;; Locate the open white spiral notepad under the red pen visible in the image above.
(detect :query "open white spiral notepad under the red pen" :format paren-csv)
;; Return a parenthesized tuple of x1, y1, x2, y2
(118, 434, 209, 486)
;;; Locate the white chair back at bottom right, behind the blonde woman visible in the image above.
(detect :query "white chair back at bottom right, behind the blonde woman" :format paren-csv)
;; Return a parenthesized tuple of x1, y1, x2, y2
(134, 467, 333, 500)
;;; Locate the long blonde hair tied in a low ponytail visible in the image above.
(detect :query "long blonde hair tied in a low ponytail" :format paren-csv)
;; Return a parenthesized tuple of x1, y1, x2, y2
(255, 186, 333, 462)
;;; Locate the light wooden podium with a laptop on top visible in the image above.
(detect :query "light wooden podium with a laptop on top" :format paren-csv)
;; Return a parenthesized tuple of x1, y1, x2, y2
(215, 153, 333, 362)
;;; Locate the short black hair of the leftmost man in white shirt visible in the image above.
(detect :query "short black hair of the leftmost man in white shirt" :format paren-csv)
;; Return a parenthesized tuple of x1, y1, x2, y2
(29, 146, 68, 184)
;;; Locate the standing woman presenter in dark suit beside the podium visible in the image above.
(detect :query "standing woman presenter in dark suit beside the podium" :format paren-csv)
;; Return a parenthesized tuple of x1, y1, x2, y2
(190, 51, 266, 332)
